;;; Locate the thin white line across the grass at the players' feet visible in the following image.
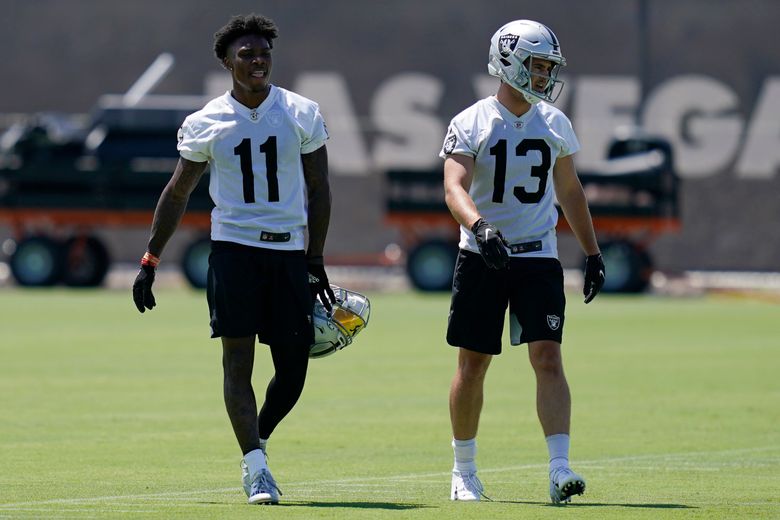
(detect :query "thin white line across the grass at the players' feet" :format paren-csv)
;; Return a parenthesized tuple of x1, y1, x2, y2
(0, 446, 780, 512)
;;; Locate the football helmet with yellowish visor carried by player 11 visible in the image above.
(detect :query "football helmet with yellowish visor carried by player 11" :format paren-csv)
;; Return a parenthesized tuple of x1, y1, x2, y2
(309, 284, 371, 358)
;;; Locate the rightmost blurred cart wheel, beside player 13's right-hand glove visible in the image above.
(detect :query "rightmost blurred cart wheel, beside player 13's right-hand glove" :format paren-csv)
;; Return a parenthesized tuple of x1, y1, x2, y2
(601, 240, 653, 293)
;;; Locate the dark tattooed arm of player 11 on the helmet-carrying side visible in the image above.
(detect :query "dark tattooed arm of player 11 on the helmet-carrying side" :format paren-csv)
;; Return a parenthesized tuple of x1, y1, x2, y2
(301, 145, 331, 257)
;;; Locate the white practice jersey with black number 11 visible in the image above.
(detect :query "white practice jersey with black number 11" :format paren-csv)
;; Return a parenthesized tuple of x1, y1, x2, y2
(178, 85, 328, 250)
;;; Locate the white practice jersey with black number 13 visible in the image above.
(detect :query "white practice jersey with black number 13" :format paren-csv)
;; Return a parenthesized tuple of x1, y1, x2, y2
(439, 96, 580, 258)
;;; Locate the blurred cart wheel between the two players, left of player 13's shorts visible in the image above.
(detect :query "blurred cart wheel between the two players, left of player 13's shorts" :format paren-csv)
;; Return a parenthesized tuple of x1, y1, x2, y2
(406, 240, 458, 291)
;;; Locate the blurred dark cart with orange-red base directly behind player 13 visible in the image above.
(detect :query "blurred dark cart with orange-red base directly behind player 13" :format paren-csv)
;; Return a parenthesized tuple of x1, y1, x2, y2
(385, 130, 681, 293)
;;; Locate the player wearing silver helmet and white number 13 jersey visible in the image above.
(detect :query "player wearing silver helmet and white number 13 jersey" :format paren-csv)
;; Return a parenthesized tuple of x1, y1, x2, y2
(440, 20, 605, 503)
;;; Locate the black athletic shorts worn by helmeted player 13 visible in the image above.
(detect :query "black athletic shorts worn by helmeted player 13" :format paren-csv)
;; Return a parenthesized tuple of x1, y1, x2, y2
(447, 249, 566, 354)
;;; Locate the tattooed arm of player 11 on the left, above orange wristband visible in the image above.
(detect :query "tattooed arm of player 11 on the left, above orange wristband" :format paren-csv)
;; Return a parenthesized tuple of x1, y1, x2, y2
(147, 157, 208, 257)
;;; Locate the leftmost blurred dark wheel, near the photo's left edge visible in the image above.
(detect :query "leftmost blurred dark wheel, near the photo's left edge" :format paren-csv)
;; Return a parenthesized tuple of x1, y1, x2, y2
(9, 236, 64, 287)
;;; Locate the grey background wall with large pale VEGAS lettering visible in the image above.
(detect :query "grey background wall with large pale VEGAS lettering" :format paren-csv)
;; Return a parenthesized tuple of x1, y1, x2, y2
(0, 0, 780, 270)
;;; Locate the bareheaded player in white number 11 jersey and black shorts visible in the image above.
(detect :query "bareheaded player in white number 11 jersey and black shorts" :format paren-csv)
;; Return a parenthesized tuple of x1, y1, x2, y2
(133, 15, 335, 504)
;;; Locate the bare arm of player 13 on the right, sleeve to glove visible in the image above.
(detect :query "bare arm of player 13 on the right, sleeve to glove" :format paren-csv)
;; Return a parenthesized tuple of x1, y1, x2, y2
(553, 155, 599, 256)
